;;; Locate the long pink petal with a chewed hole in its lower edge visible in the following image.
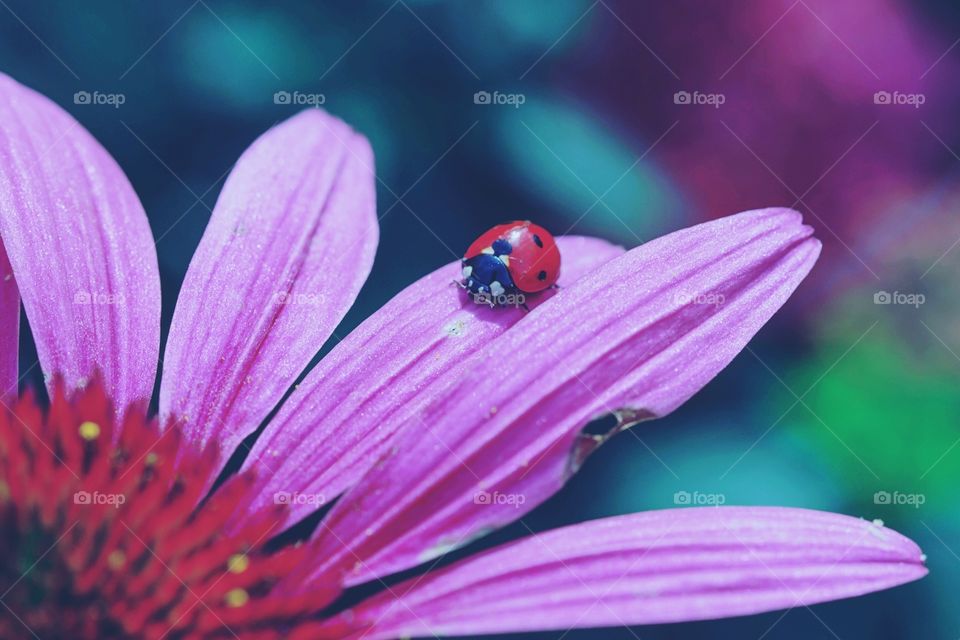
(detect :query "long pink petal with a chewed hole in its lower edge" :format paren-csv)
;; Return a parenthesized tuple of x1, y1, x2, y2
(304, 209, 820, 584)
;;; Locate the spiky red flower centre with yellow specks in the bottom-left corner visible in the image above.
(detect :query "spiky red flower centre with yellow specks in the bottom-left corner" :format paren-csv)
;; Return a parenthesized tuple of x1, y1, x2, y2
(0, 382, 338, 640)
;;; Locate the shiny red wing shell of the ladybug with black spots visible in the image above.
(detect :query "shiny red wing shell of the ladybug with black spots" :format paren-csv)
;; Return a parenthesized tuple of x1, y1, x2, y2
(463, 220, 560, 293)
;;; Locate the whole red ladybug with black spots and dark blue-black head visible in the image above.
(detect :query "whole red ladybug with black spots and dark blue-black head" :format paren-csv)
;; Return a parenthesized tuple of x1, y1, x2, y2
(460, 220, 560, 307)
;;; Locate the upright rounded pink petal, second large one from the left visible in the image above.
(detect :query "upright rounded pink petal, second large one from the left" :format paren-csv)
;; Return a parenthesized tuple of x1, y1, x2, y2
(160, 109, 378, 468)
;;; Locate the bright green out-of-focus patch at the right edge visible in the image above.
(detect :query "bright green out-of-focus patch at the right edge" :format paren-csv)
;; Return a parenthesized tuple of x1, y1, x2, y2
(791, 321, 960, 516)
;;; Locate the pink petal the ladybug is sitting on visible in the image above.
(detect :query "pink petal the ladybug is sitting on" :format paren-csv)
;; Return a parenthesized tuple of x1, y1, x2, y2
(240, 236, 623, 521)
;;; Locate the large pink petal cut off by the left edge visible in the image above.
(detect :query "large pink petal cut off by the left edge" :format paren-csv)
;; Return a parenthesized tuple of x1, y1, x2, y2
(0, 75, 160, 407)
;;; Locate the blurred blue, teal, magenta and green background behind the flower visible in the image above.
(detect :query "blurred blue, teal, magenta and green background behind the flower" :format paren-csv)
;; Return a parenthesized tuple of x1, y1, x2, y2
(0, 0, 960, 639)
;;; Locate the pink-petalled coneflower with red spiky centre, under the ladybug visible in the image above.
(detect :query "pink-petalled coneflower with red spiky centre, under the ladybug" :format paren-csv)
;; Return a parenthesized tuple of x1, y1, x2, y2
(0, 72, 926, 639)
